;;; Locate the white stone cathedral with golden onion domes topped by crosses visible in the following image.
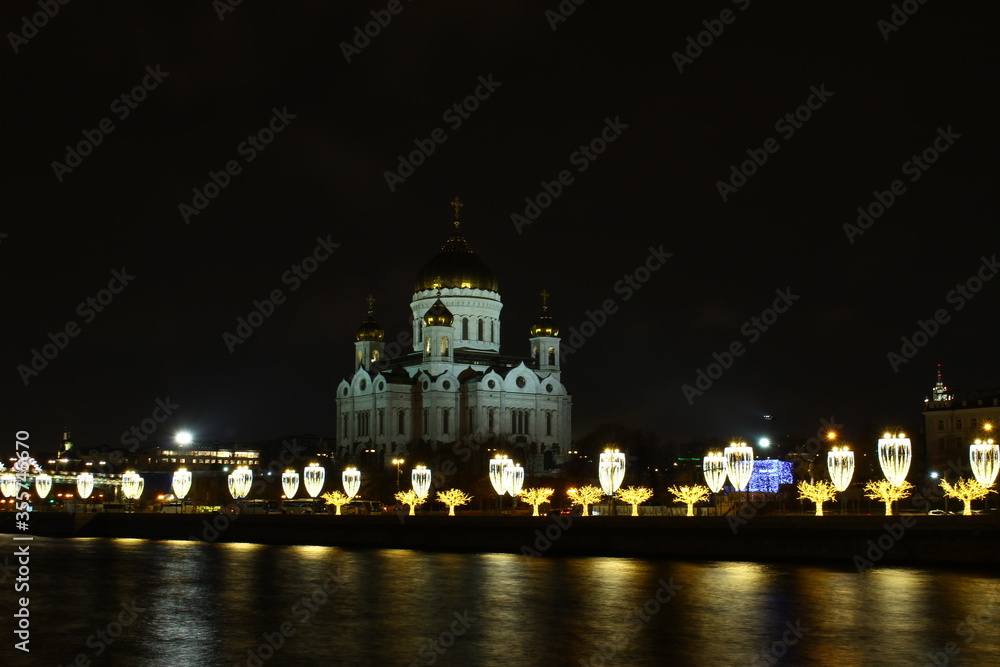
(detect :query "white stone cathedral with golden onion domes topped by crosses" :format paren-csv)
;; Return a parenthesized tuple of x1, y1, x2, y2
(336, 197, 572, 475)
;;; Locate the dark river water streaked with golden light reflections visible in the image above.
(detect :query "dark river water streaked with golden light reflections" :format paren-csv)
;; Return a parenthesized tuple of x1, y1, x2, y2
(0, 538, 1000, 667)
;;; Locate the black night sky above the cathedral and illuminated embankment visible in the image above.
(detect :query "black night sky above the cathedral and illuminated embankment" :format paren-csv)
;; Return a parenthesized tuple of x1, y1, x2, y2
(0, 0, 1000, 456)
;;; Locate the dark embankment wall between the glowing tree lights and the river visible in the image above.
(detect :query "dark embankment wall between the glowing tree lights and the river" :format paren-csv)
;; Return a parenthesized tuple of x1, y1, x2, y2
(0, 512, 1000, 567)
